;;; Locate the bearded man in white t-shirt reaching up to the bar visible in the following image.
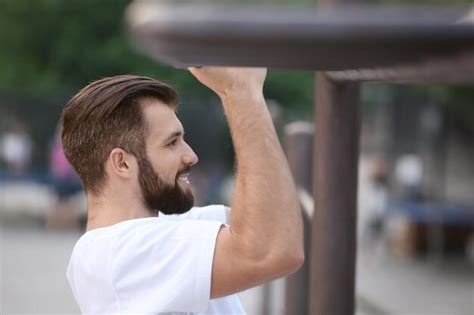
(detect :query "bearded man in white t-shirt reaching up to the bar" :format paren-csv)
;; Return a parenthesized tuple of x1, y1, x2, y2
(62, 68, 304, 314)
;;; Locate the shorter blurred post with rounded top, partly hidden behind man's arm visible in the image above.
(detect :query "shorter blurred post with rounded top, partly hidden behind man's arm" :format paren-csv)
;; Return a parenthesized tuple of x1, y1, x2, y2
(285, 121, 314, 315)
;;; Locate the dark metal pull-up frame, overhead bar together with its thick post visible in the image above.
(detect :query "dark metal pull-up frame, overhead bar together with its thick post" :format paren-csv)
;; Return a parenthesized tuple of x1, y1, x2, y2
(126, 0, 474, 315)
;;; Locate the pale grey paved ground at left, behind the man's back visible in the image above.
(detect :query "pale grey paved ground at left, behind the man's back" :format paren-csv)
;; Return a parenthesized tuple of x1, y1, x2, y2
(0, 224, 79, 315)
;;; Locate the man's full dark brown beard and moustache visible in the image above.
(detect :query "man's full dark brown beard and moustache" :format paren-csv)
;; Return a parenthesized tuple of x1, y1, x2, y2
(137, 156, 194, 215)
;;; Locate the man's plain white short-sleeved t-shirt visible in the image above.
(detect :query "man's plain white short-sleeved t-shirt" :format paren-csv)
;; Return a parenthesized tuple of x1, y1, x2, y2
(67, 206, 245, 314)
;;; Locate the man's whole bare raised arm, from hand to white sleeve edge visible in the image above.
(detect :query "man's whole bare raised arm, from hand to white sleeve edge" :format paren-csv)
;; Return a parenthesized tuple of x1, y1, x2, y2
(190, 68, 304, 298)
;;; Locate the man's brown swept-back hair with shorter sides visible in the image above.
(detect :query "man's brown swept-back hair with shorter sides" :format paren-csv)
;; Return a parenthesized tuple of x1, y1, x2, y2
(61, 75, 178, 194)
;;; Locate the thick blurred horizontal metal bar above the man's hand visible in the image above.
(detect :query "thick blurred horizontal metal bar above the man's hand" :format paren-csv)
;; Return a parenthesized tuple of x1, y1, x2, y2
(127, 1, 474, 81)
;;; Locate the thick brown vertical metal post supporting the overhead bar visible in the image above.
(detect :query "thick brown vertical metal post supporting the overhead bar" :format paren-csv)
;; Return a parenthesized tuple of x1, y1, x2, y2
(310, 73, 360, 315)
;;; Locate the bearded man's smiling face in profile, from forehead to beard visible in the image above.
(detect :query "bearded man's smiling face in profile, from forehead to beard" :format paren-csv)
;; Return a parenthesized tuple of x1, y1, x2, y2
(137, 100, 197, 214)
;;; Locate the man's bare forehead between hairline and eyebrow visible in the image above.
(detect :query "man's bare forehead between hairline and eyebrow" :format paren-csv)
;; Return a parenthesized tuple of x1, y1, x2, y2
(143, 99, 183, 140)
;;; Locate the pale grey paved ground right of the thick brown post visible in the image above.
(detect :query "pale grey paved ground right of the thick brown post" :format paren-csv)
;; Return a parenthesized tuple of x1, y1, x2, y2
(357, 251, 474, 315)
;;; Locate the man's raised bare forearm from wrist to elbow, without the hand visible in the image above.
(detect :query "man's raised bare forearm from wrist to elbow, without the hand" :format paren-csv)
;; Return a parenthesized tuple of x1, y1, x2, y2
(222, 91, 303, 266)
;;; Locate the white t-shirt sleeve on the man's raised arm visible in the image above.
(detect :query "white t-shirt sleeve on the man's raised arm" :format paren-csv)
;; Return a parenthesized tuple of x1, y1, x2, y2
(111, 220, 222, 314)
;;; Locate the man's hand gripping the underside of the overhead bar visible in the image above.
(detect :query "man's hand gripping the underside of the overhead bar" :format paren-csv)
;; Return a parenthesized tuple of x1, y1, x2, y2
(189, 67, 267, 99)
